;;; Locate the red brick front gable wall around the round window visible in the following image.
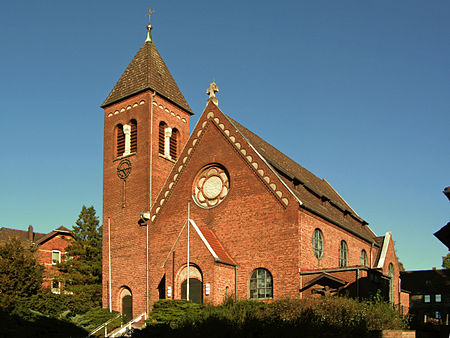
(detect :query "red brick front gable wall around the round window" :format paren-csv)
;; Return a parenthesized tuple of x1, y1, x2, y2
(151, 109, 299, 306)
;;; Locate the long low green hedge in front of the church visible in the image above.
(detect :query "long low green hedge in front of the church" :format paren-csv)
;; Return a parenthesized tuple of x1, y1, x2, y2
(135, 297, 407, 338)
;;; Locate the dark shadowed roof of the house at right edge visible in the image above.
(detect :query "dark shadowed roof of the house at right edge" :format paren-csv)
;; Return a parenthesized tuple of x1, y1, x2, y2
(400, 270, 450, 294)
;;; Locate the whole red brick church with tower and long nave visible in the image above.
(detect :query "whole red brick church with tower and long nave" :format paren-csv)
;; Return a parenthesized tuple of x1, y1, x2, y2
(102, 25, 400, 317)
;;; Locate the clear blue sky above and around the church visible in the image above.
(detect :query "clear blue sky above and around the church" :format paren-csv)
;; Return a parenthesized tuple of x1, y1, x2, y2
(0, 0, 450, 270)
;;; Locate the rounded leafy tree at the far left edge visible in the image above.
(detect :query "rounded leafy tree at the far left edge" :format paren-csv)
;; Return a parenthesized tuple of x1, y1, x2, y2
(0, 238, 44, 311)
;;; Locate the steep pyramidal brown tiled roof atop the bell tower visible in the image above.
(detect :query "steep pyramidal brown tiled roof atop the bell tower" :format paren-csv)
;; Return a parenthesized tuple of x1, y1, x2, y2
(102, 41, 192, 114)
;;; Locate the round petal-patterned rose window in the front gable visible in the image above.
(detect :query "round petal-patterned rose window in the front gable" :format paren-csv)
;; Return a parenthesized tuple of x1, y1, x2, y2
(192, 164, 230, 208)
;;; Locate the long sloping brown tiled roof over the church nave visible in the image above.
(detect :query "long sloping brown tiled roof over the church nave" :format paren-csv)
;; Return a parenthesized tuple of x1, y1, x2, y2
(224, 114, 376, 242)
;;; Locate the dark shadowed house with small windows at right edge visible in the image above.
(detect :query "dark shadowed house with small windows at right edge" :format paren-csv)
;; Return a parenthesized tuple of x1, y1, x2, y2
(400, 270, 450, 325)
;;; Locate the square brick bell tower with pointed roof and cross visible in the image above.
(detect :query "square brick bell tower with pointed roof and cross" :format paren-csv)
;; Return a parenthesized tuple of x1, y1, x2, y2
(101, 11, 193, 317)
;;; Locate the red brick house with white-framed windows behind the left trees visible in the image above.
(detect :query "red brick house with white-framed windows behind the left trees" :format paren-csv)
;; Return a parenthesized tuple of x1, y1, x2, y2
(0, 225, 73, 293)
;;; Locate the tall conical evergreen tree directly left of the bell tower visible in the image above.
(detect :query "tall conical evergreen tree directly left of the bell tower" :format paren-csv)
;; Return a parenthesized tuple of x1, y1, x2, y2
(58, 205, 102, 306)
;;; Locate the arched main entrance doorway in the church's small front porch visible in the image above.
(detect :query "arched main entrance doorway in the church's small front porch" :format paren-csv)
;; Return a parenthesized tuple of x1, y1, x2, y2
(177, 263, 203, 304)
